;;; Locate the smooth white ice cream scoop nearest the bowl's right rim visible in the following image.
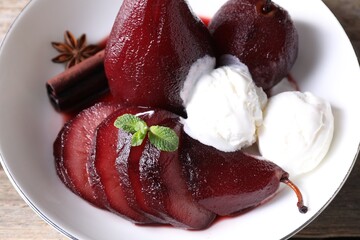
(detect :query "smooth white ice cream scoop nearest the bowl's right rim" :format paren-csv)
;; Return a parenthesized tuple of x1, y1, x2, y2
(258, 91, 334, 176)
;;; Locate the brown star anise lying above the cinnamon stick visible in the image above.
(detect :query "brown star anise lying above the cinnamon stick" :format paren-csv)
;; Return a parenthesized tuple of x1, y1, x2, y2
(51, 31, 99, 68)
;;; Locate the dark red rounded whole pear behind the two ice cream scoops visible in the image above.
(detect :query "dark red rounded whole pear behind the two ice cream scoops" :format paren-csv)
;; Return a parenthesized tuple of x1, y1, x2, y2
(209, 0, 299, 91)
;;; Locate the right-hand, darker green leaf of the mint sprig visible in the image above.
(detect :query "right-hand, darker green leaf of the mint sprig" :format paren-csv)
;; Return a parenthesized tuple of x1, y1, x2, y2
(149, 126, 179, 152)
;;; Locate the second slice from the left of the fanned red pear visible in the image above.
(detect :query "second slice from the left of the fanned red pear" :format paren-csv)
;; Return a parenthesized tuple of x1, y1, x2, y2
(88, 107, 157, 224)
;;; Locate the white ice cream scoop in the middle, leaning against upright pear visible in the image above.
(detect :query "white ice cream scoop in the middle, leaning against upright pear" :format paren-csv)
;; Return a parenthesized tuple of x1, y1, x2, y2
(183, 63, 267, 152)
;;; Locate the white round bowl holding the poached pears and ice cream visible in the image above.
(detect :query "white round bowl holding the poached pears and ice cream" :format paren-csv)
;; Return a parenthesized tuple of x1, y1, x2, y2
(0, 0, 360, 240)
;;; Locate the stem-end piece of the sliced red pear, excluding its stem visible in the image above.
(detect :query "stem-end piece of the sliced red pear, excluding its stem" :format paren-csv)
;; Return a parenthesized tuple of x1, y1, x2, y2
(180, 133, 287, 216)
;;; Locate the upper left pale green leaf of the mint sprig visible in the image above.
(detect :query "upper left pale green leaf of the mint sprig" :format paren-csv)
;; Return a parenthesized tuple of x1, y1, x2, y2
(114, 114, 148, 135)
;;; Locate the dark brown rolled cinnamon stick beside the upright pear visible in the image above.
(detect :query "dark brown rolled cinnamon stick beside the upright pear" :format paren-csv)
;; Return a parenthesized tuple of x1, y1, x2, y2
(46, 50, 109, 112)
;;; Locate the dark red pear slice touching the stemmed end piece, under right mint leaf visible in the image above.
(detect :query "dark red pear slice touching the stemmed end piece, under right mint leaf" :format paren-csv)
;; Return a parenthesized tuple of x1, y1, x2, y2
(139, 113, 215, 229)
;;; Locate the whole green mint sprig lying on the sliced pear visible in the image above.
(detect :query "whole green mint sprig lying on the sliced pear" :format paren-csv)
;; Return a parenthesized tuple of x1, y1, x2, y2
(114, 114, 179, 152)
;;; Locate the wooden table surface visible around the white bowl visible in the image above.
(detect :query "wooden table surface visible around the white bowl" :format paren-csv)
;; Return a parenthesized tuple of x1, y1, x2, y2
(0, 0, 360, 240)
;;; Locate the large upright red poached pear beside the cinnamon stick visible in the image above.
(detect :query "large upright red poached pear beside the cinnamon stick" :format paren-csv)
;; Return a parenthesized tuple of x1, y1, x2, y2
(105, 0, 214, 113)
